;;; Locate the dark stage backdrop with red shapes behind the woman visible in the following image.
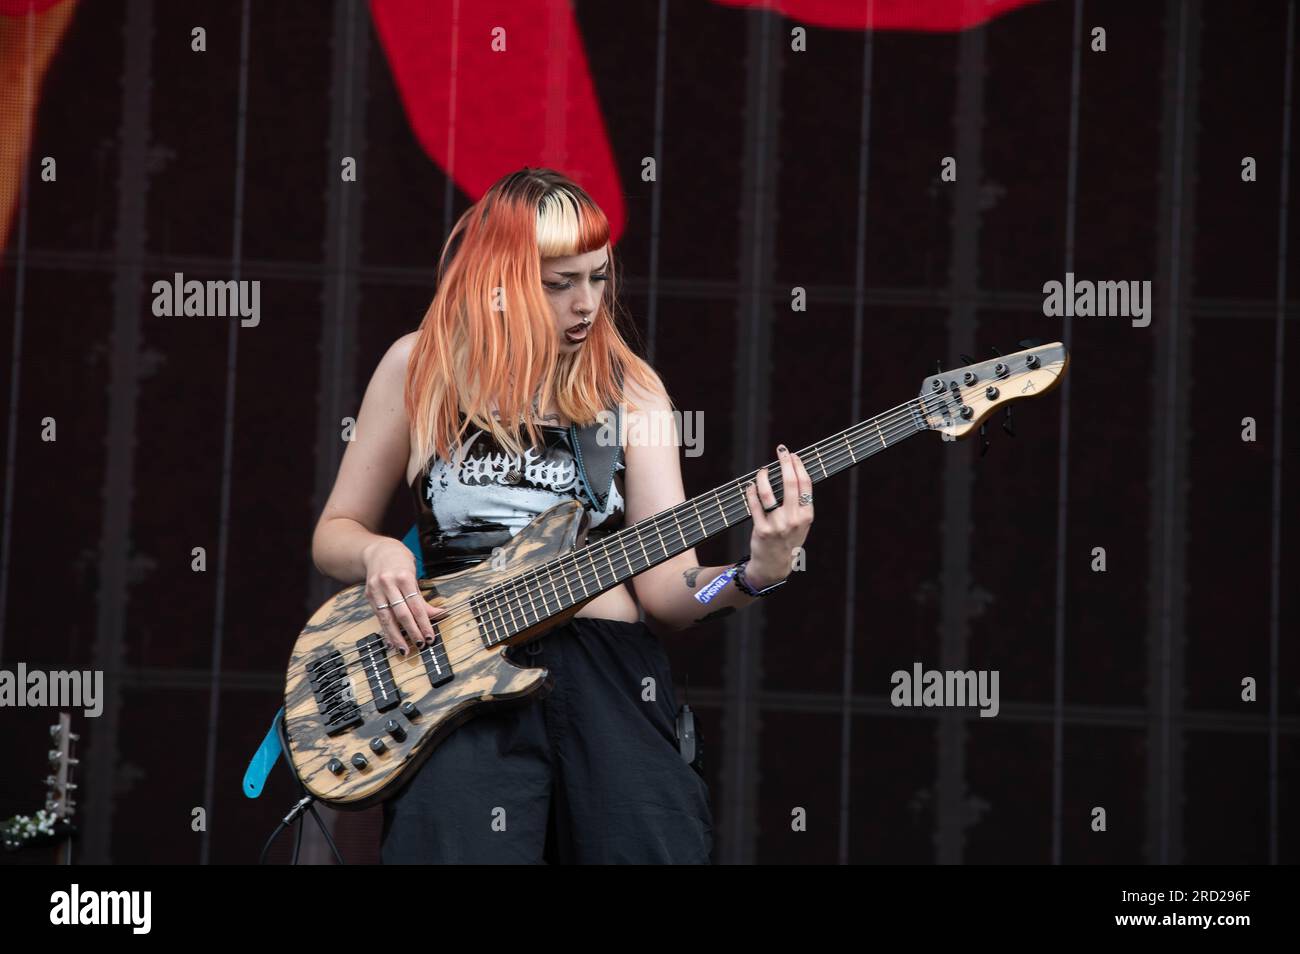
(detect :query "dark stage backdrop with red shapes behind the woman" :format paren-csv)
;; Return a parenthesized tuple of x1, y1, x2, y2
(0, 0, 1300, 863)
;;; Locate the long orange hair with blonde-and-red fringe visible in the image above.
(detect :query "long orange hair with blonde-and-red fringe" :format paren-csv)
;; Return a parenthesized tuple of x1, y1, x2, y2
(406, 168, 663, 475)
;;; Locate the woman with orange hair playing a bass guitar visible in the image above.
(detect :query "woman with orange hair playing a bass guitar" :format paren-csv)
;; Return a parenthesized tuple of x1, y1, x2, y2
(312, 169, 813, 863)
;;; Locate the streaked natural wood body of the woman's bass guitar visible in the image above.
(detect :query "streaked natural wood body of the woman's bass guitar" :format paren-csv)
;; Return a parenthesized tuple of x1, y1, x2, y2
(285, 500, 594, 808)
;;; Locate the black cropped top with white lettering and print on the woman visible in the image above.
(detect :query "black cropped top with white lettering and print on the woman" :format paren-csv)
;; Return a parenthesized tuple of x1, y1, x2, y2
(411, 415, 625, 577)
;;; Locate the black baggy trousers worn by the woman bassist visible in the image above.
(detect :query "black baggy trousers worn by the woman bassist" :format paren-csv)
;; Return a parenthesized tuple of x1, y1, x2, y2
(380, 616, 712, 864)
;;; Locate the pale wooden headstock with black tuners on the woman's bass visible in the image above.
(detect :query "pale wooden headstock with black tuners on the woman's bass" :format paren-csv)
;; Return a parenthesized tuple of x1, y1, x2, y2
(919, 342, 1070, 441)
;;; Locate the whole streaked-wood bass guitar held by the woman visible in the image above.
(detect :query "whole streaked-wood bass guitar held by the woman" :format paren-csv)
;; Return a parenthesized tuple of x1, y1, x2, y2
(285, 342, 1069, 808)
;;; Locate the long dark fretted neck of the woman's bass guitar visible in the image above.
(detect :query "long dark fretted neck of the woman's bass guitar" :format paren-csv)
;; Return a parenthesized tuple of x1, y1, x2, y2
(475, 399, 928, 638)
